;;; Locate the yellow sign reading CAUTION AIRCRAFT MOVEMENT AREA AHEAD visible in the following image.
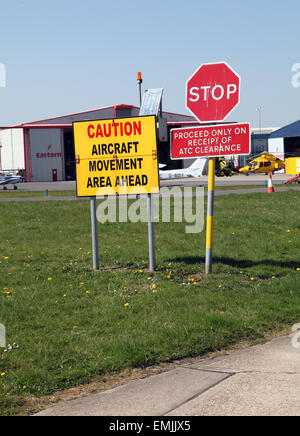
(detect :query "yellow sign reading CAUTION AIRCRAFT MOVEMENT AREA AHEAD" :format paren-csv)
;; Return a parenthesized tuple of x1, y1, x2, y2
(73, 115, 159, 197)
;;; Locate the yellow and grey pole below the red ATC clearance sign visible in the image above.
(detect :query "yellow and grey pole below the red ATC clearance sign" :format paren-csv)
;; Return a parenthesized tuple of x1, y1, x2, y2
(205, 157, 216, 274)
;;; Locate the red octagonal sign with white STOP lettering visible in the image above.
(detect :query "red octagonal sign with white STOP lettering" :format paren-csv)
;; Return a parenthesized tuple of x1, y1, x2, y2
(186, 62, 241, 122)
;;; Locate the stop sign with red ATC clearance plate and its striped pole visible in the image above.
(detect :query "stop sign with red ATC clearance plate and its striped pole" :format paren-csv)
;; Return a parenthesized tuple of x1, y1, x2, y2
(179, 62, 245, 274)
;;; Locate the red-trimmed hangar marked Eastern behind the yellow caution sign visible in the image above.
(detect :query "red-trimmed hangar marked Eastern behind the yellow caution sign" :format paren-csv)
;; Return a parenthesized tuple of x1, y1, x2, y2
(0, 104, 195, 182)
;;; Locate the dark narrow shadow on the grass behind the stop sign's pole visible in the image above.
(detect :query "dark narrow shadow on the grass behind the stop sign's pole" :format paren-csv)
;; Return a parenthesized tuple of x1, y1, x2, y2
(172, 256, 300, 271)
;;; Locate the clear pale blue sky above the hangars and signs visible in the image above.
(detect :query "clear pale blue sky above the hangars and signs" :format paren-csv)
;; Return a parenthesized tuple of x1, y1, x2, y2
(0, 0, 300, 127)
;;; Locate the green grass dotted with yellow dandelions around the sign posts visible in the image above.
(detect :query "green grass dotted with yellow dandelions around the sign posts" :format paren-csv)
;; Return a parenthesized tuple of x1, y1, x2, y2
(0, 191, 300, 415)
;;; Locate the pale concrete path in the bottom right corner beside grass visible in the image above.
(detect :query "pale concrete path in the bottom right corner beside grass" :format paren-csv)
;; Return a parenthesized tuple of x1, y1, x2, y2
(37, 336, 300, 416)
